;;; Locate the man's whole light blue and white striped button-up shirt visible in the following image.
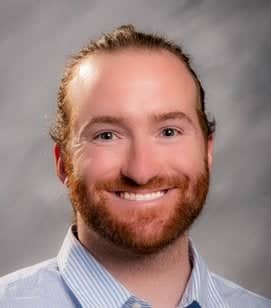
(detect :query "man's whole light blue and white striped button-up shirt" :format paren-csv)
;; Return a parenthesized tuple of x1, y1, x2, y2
(0, 226, 271, 308)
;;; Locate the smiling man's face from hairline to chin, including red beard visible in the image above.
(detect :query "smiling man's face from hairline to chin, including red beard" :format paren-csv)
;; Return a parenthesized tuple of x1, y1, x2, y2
(58, 50, 214, 254)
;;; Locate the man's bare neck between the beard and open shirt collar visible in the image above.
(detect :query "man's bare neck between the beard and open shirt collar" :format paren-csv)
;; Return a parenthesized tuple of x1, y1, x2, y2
(77, 221, 191, 308)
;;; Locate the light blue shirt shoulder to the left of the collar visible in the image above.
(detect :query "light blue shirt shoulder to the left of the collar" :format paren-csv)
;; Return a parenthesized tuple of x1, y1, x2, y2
(0, 258, 73, 308)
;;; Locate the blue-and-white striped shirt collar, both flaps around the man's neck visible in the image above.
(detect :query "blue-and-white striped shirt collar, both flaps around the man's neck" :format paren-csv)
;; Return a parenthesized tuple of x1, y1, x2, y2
(57, 225, 224, 308)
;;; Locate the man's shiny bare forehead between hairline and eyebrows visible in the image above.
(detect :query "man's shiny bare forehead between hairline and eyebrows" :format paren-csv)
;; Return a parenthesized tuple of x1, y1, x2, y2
(68, 50, 199, 121)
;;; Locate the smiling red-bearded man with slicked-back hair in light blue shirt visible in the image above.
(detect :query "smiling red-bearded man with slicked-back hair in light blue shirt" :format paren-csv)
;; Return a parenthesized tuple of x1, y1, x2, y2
(0, 25, 271, 308)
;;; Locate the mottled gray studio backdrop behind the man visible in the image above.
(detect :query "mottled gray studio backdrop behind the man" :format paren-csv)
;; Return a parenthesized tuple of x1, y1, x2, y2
(0, 0, 271, 297)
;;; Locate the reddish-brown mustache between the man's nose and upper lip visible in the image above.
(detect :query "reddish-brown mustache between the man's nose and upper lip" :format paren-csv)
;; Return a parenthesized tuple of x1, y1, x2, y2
(94, 175, 189, 191)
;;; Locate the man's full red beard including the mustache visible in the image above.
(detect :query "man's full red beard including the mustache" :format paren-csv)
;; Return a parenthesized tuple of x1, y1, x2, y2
(68, 161, 209, 255)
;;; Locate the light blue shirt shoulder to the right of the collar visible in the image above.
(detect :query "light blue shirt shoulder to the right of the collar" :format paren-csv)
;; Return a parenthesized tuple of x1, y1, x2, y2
(210, 273, 271, 308)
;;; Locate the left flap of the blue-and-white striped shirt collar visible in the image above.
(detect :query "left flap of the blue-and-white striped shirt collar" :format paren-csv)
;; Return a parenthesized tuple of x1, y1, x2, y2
(57, 226, 134, 308)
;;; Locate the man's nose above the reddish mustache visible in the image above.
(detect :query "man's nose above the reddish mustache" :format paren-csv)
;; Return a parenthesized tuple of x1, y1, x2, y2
(121, 141, 161, 185)
